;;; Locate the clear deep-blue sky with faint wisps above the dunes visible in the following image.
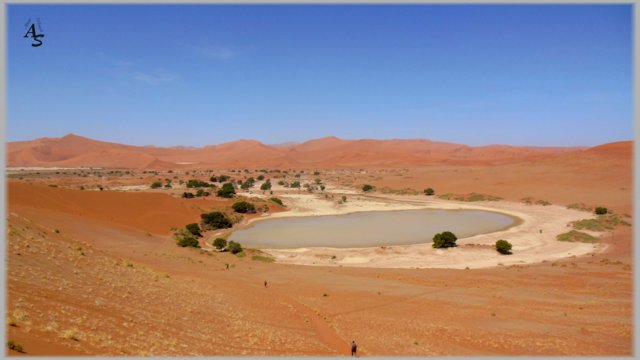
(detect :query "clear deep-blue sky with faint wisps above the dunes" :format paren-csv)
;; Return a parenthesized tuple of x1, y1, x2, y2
(7, 5, 633, 146)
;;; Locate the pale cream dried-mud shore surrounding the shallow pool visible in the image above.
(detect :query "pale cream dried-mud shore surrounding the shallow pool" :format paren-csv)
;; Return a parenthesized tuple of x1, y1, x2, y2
(252, 194, 604, 269)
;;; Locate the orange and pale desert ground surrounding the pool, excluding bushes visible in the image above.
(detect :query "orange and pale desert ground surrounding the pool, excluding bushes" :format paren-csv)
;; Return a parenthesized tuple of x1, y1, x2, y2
(6, 136, 634, 356)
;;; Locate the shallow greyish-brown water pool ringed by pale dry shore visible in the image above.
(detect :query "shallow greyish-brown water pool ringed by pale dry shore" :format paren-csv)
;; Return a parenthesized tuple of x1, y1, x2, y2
(229, 209, 515, 249)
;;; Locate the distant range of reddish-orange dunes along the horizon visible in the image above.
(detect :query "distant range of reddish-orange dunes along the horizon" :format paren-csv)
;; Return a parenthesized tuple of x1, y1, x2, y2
(8, 134, 612, 169)
